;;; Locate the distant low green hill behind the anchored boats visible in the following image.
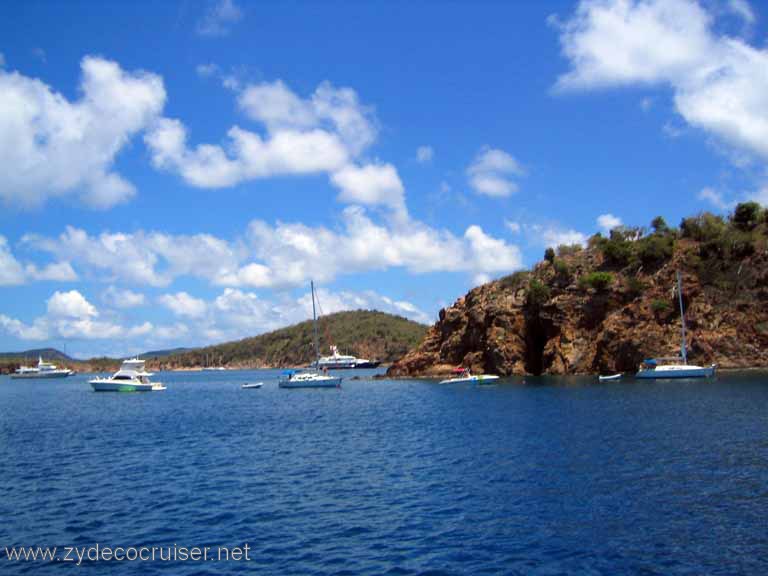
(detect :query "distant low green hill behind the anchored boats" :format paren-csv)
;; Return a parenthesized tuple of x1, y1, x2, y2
(155, 310, 427, 369)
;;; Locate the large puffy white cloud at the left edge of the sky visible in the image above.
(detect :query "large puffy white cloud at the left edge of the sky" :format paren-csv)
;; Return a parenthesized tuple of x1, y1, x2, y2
(0, 56, 165, 208)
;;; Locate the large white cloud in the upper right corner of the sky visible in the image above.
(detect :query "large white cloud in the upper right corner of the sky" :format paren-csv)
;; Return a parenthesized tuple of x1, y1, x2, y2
(557, 0, 768, 157)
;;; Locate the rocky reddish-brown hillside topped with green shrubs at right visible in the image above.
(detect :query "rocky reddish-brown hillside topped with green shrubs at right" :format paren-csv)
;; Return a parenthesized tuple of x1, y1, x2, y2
(388, 203, 768, 376)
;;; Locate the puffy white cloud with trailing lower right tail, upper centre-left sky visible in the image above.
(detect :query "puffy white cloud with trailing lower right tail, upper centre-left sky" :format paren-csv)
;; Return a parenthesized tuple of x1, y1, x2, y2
(145, 79, 414, 218)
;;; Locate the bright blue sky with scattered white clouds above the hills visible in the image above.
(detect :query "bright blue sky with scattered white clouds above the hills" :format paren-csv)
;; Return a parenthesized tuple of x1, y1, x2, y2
(0, 0, 768, 358)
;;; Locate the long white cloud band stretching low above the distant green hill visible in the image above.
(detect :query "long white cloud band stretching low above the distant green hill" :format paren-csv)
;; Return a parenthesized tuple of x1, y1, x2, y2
(25, 206, 521, 290)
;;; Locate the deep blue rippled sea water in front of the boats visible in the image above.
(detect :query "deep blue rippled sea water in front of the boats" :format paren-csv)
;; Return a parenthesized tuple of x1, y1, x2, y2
(0, 372, 768, 575)
